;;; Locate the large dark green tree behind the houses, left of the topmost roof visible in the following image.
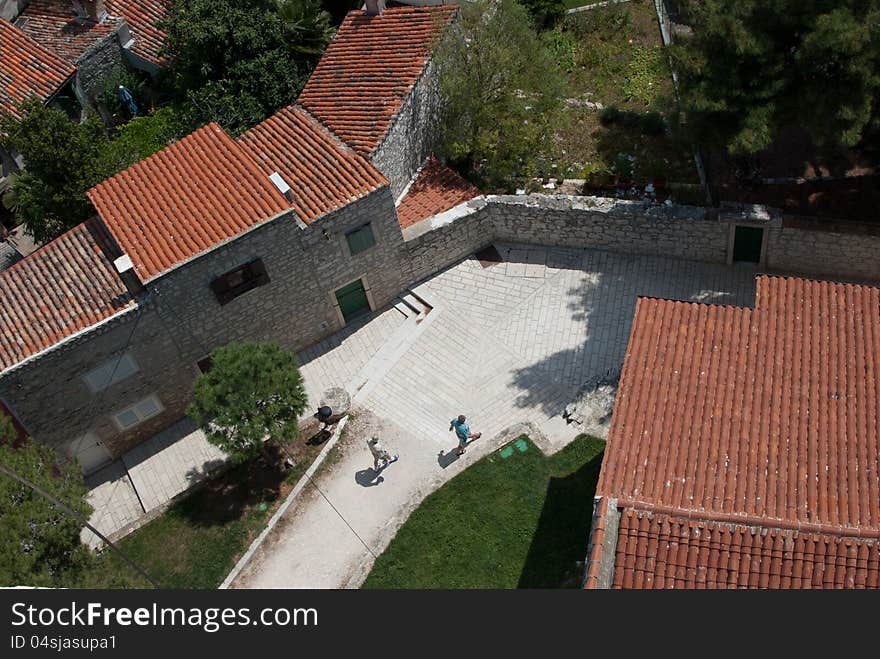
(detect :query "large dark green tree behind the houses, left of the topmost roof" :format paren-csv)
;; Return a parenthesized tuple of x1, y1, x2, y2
(163, 0, 332, 132)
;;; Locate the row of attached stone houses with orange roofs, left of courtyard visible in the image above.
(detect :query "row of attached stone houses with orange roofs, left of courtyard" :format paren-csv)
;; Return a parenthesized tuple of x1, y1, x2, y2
(0, 3, 464, 470)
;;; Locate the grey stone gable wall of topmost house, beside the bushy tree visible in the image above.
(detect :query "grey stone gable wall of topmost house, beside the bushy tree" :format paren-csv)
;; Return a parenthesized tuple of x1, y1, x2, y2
(371, 62, 440, 199)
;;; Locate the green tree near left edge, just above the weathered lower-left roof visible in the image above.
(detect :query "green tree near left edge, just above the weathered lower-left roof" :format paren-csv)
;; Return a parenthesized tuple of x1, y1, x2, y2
(0, 100, 107, 242)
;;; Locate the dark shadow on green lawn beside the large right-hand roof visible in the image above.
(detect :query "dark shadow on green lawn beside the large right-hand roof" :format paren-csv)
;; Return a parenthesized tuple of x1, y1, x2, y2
(517, 453, 604, 588)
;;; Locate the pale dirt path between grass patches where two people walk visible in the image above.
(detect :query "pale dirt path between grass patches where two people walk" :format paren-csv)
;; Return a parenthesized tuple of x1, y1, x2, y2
(232, 408, 528, 588)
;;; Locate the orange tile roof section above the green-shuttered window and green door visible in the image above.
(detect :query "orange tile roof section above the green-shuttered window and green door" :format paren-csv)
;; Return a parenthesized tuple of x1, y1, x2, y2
(239, 106, 387, 223)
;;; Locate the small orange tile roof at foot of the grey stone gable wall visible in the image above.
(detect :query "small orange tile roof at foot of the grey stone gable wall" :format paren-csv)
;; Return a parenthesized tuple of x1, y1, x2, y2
(397, 156, 481, 229)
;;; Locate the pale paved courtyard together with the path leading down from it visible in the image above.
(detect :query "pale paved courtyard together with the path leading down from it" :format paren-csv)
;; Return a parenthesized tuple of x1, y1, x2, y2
(233, 245, 755, 588)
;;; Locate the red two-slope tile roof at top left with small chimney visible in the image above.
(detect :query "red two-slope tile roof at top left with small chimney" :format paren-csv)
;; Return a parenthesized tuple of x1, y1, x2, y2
(20, 0, 171, 66)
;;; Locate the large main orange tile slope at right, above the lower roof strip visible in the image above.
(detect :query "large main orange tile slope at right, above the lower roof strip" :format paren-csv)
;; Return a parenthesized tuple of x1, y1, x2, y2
(588, 276, 880, 585)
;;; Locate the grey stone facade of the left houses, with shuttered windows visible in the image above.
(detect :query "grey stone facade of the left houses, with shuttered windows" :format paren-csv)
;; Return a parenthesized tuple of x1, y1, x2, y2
(0, 187, 407, 456)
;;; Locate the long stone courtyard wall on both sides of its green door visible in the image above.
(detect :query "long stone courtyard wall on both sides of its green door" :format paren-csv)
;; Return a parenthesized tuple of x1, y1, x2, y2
(403, 195, 880, 288)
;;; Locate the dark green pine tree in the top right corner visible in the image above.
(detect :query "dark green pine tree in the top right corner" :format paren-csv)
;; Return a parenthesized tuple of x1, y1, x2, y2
(672, 0, 880, 155)
